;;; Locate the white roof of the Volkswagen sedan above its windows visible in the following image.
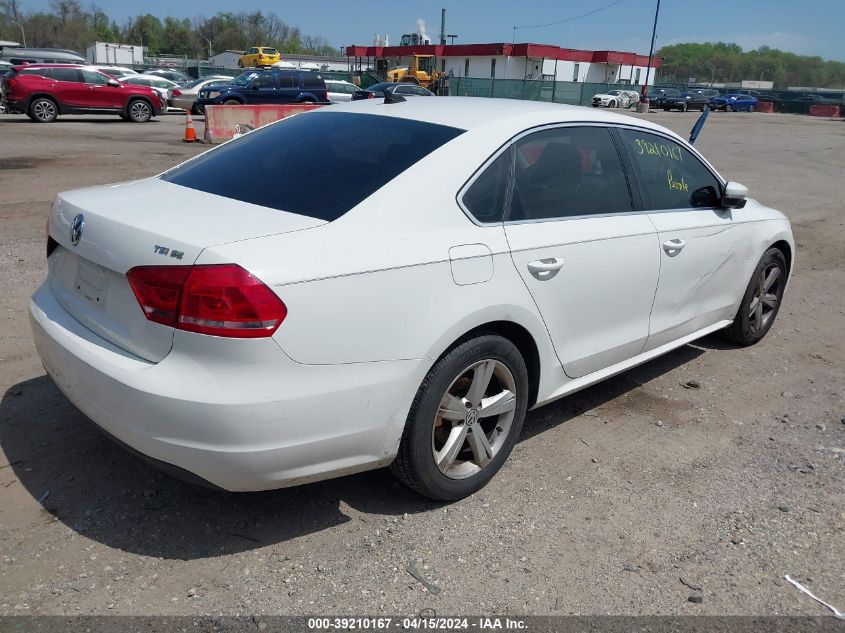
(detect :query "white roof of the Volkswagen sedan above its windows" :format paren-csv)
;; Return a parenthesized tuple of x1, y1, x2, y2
(320, 97, 680, 138)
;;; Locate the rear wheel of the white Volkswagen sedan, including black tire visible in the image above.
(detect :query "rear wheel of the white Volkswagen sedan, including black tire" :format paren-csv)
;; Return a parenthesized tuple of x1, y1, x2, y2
(390, 334, 528, 501)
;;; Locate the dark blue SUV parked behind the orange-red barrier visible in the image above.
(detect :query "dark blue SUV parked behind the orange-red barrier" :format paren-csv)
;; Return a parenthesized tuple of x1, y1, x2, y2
(196, 68, 329, 110)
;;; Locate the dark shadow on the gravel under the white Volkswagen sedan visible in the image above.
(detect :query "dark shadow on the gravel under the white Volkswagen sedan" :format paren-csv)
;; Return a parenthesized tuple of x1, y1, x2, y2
(0, 346, 704, 560)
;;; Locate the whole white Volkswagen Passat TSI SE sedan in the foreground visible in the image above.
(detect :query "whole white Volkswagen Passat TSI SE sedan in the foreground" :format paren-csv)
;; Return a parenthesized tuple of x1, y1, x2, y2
(30, 97, 795, 499)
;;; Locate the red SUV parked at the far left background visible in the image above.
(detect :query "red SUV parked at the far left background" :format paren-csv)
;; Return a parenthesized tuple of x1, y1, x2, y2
(0, 64, 167, 123)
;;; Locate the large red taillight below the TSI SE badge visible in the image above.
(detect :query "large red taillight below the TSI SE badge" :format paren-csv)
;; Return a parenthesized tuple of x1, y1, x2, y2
(126, 264, 287, 338)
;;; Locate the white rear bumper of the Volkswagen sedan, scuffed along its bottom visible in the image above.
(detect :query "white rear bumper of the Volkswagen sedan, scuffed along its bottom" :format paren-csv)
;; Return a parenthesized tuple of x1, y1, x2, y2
(30, 283, 426, 491)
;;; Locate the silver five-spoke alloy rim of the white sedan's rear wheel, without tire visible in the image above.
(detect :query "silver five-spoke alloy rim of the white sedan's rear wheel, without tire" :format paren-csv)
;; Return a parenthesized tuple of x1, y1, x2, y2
(431, 359, 517, 479)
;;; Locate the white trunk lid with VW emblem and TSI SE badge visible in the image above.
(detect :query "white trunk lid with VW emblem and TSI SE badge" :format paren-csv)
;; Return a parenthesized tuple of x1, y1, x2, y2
(48, 178, 325, 362)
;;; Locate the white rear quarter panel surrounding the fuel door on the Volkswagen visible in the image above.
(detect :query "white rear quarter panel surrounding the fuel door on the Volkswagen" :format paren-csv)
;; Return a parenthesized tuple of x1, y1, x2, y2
(198, 115, 556, 364)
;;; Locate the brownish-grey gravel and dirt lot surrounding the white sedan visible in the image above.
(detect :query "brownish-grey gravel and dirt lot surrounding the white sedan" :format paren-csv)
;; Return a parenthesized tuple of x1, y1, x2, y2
(0, 113, 845, 615)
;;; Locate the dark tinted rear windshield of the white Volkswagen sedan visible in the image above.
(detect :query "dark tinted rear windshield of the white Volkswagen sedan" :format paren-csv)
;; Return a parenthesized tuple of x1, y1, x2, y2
(161, 112, 464, 222)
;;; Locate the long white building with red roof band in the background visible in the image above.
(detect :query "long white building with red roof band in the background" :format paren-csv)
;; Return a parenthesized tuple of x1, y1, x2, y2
(346, 43, 661, 85)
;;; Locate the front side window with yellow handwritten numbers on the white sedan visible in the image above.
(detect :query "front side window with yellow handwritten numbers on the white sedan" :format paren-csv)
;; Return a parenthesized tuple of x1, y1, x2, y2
(620, 130, 722, 209)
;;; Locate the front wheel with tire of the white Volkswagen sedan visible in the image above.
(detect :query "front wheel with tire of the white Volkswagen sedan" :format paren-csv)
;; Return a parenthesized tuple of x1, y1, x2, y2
(725, 248, 788, 346)
